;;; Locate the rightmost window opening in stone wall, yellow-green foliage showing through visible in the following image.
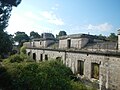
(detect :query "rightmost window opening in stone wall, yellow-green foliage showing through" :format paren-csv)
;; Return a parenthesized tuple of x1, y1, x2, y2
(91, 63, 99, 79)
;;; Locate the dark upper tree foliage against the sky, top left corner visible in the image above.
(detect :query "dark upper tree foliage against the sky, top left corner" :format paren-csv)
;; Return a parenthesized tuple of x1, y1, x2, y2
(0, 0, 21, 31)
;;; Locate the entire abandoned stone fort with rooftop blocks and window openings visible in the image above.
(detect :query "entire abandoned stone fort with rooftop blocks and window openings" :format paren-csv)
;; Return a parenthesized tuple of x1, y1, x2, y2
(24, 30, 120, 90)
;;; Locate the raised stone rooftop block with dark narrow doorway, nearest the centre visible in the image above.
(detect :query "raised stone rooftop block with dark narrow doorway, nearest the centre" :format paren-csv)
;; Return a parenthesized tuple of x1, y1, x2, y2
(59, 34, 90, 49)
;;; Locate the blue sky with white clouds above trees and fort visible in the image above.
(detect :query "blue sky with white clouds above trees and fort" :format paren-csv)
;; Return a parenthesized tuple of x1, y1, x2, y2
(6, 0, 120, 35)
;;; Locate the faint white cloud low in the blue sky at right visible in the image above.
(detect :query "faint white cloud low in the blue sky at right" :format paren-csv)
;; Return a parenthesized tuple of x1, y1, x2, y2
(81, 23, 113, 31)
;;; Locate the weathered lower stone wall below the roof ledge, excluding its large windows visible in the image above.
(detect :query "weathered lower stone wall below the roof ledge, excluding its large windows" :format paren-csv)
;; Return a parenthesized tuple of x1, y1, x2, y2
(27, 49, 120, 90)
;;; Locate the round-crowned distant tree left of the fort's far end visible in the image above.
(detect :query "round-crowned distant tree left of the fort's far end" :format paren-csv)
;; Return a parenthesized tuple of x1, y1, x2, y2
(14, 31, 30, 47)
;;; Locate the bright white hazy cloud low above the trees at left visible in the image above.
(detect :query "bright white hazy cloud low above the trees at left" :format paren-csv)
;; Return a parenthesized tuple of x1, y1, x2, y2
(6, 14, 52, 35)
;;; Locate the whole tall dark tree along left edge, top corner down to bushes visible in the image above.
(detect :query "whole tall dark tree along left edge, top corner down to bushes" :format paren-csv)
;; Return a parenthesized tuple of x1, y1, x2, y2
(0, 0, 21, 57)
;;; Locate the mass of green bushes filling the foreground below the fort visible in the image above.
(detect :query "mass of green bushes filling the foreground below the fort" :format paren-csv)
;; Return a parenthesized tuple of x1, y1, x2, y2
(0, 50, 96, 90)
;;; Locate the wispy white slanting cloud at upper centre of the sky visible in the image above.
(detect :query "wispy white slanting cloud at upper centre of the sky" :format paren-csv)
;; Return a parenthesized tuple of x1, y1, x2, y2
(41, 11, 64, 25)
